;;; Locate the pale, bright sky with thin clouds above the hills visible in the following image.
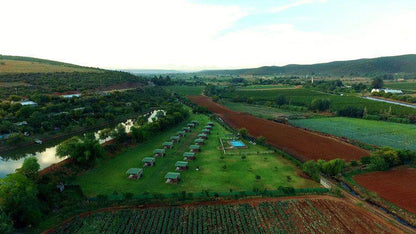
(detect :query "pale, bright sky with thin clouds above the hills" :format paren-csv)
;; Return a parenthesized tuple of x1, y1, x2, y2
(0, 0, 416, 70)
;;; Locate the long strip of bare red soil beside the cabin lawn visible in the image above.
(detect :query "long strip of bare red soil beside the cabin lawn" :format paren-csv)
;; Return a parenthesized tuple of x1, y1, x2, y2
(188, 96, 370, 161)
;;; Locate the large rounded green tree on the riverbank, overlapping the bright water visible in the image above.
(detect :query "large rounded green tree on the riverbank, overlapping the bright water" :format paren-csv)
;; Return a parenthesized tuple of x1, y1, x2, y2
(56, 133, 105, 166)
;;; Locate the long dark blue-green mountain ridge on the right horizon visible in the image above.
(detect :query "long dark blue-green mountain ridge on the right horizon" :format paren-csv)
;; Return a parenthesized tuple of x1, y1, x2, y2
(201, 54, 416, 76)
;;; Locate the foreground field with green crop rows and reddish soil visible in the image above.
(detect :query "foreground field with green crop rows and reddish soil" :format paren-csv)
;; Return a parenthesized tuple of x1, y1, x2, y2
(51, 196, 400, 233)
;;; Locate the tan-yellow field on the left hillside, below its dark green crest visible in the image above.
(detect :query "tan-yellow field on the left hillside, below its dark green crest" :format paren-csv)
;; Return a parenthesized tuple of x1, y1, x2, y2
(0, 59, 99, 74)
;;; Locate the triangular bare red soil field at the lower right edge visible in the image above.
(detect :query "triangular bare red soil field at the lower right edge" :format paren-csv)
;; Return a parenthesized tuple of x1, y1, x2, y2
(354, 167, 416, 214)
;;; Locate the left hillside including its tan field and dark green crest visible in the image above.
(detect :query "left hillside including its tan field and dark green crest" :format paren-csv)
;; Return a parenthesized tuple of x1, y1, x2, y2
(0, 55, 101, 74)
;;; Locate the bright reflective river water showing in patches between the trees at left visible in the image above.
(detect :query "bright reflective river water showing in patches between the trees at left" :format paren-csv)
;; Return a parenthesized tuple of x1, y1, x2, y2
(0, 110, 166, 178)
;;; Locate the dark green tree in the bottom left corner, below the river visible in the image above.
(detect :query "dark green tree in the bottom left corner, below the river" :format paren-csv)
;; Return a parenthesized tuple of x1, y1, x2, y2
(0, 173, 41, 227)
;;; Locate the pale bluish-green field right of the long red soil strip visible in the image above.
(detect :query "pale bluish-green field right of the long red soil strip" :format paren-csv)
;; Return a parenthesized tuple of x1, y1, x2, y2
(289, 117, 416, 150)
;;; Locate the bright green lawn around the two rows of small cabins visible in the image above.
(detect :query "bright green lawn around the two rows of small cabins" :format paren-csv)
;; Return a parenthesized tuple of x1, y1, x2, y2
(75, 115, 320, 196)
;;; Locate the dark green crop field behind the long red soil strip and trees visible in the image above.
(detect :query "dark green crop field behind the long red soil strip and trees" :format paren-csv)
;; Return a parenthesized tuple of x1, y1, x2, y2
(224, 88, 416, 116)
